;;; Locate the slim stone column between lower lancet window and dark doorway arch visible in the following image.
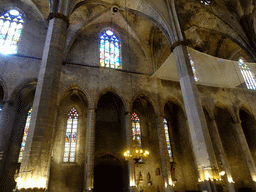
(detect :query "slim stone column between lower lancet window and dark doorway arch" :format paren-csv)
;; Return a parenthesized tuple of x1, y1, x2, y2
(85, 109, 96, 191)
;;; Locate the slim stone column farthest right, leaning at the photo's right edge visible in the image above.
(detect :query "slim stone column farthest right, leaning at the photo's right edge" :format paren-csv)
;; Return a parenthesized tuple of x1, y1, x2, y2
(234, 121, 256, 187)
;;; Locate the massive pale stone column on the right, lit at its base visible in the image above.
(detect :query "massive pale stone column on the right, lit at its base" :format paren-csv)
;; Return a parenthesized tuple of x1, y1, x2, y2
(165, 0, 217, 192)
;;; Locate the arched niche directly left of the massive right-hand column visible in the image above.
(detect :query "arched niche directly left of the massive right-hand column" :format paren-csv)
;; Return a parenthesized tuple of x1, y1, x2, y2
(164, 102, 198, 191)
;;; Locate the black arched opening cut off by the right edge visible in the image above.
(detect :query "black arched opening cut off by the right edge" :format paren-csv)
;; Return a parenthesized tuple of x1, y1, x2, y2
(239, 109, 256, 162)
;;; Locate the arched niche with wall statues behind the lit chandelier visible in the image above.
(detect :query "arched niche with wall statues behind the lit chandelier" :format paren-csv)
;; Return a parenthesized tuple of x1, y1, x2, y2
(130, 95, 164, 191)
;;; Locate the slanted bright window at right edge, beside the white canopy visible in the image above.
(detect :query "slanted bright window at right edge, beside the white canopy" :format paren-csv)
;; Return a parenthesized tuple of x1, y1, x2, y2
(239, 58, 256, 90)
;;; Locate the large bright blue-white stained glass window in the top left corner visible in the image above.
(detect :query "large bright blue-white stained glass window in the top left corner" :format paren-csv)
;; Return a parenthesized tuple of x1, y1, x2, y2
(0, 9, 24, 54)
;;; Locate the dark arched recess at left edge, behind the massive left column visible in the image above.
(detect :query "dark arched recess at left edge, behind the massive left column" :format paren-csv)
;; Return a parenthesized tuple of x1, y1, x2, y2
(0, 83, 35, 191)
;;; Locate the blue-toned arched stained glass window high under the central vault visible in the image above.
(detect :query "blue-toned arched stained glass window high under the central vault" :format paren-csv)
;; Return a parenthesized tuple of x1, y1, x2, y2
(100, 29, 121, 69)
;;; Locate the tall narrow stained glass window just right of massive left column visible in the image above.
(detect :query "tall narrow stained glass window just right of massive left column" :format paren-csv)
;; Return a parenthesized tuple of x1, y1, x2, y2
(63, 107, 78, 162)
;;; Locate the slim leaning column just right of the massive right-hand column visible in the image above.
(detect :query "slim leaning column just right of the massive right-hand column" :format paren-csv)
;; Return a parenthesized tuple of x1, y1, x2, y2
(209, 119, 235, 192)
